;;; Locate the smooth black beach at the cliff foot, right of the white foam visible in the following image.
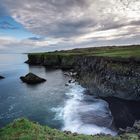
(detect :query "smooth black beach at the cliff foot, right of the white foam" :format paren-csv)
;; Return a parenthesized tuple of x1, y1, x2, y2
(103, 97, 140, 129)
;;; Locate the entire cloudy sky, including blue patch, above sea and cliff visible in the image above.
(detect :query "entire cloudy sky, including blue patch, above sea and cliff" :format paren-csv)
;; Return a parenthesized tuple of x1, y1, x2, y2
(0, 0, 140, 52)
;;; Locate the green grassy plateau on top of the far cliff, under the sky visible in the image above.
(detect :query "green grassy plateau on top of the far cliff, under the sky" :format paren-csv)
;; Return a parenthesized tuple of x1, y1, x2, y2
(29, 45, 140, 58)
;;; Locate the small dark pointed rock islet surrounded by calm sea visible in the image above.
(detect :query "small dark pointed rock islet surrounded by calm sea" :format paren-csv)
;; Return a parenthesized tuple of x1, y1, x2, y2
(20, 73, 46, 84)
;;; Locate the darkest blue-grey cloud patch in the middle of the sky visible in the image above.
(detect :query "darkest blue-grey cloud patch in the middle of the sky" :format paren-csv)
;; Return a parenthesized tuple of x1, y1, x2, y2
(42, 19, 97, 38)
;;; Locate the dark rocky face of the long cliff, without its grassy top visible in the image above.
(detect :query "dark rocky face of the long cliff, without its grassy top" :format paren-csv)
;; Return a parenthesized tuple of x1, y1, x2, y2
(28, 54, 140, 100)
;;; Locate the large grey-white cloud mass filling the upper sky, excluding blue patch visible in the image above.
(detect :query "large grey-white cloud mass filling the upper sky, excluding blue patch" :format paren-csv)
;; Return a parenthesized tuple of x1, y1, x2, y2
(0, 0, 140, 52)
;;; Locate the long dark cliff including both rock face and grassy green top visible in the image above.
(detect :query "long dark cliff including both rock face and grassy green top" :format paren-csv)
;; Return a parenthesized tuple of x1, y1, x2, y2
(27, 45, 140, 100)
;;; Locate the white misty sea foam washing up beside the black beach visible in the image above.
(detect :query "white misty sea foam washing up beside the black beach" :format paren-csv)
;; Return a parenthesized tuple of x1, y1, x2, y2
(53, 83, 116, 135)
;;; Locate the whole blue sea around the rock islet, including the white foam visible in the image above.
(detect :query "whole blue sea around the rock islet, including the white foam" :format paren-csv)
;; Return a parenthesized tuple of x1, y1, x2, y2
(0, 54, 116, 135)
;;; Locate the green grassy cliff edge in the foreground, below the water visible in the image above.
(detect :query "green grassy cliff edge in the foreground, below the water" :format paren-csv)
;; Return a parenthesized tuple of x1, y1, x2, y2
(0, 118, 140, 140)
